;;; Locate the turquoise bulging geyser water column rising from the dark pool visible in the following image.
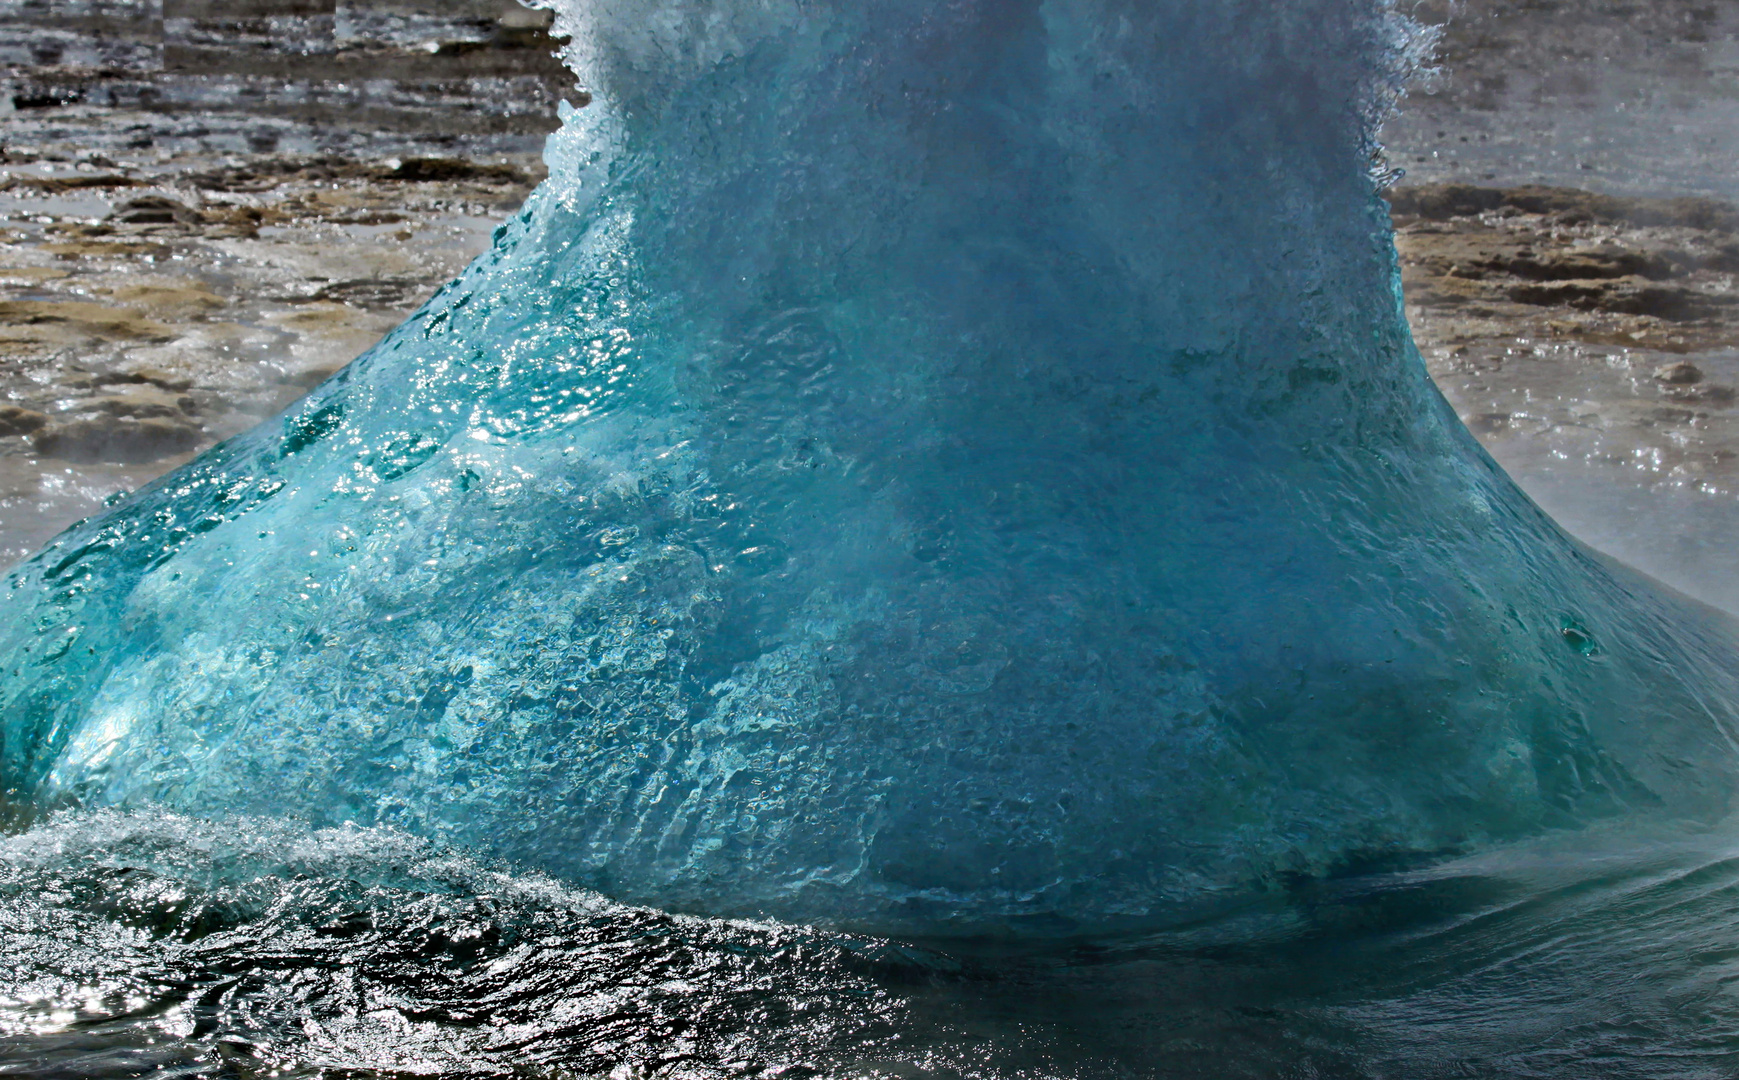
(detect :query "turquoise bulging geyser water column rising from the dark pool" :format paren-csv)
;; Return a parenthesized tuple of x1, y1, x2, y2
(0, 0, 1736, 925)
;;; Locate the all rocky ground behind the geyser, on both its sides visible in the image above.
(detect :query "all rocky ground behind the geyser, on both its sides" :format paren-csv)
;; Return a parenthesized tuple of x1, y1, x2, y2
(0, 0, 1739, 609)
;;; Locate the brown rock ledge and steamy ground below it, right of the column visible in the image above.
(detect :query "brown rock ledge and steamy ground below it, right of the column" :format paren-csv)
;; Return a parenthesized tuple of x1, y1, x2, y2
(1389, 184, 1739, 607)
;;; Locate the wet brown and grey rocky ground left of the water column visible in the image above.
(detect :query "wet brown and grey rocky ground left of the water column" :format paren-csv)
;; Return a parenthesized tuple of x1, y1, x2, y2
(0, 0, 570, 560)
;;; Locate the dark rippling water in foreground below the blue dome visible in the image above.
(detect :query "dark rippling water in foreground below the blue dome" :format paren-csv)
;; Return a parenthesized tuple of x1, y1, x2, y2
(16, 810, 1739, 1080)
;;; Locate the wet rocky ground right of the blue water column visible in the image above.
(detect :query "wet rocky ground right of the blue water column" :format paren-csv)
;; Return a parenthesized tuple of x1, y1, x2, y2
(1383, 0, 1739, 612)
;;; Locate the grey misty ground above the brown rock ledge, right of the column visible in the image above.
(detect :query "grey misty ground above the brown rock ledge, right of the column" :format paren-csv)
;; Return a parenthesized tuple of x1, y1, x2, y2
(1384, 0, 1739, 200)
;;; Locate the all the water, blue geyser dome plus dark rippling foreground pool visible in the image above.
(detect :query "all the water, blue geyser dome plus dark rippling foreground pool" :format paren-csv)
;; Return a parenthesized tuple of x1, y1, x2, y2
(0, 0, 1739, 1077)
